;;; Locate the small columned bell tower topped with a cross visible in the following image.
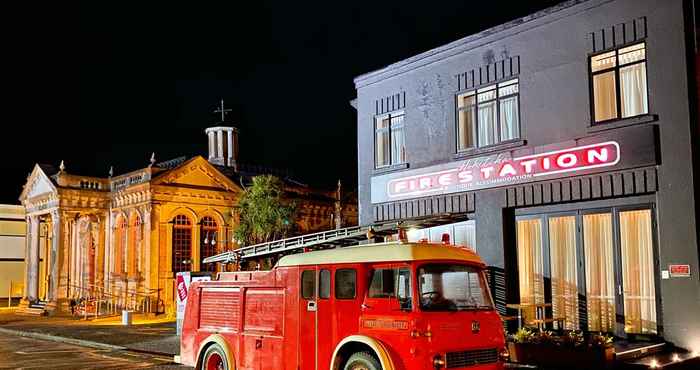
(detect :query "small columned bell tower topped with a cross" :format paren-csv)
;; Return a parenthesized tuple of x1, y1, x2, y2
(204, 99, 238, 171)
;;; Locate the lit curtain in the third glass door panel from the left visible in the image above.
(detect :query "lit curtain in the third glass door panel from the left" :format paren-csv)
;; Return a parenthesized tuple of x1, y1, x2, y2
(583, 213, 615, 332)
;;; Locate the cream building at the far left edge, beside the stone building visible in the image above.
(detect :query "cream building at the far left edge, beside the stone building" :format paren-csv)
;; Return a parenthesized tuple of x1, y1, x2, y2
(0, 204, 25, 305)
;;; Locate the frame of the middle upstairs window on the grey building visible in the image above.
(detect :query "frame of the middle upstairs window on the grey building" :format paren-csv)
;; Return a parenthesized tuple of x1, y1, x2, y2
(455, 76, 523, 154)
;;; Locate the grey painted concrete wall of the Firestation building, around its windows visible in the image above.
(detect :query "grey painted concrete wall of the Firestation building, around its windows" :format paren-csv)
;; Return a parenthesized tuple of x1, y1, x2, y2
(355, 0, 700, 349)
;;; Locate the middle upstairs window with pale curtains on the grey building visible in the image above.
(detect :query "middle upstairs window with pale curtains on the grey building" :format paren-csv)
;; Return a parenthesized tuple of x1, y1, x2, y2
(457, 79, 520, 151)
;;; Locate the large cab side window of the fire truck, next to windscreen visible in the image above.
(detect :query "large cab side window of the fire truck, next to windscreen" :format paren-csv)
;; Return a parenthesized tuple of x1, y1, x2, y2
(369, 268, 412, 310)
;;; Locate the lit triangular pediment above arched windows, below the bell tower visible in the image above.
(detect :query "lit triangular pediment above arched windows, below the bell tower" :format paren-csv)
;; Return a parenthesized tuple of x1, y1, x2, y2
(152, 156, 241, 192)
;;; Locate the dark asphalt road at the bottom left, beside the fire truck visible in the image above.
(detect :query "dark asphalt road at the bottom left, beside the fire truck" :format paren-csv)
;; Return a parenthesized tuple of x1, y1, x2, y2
(0, 335, 191, 370)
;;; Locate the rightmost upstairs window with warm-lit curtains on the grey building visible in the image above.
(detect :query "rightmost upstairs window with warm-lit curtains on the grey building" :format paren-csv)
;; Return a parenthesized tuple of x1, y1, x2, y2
(591, 43, 649, 122)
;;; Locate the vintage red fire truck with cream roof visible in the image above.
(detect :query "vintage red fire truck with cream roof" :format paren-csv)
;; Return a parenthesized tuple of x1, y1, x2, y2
(180, 242, 508, 370)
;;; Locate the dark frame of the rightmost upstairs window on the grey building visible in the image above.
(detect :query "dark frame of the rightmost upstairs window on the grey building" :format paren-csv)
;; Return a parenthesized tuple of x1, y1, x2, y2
(587, 40, 651, 126)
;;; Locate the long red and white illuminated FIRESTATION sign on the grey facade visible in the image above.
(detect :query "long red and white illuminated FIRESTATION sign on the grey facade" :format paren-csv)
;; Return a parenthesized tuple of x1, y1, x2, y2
(386, 141, 620, 199)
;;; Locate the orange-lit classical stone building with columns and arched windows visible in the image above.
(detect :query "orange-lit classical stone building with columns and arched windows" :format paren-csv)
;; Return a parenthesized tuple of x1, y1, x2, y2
(20, 118, 357, 315)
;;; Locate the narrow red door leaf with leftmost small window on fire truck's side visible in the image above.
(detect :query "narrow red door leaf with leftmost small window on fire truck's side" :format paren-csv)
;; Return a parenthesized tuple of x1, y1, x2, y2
(298, 268, 318, 370)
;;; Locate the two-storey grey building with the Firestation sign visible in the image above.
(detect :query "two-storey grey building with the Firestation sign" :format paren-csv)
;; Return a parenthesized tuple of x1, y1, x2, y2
(354, 0, 700, 350)
